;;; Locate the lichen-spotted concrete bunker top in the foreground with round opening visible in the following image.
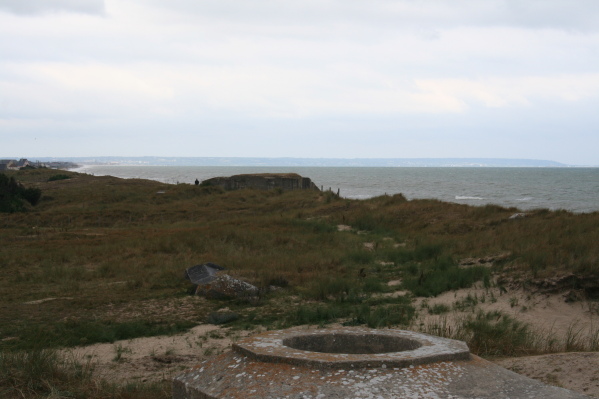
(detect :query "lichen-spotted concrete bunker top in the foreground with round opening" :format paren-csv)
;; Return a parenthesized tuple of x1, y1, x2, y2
(173, 327, 588, 399)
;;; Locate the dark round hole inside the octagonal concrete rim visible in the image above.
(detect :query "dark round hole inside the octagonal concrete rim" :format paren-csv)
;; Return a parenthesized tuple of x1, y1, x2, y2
(283, 333, 422, 354)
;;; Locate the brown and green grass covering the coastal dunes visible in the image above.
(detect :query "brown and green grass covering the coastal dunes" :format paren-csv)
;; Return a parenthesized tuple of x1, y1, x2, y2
(0, 169, 599, 398)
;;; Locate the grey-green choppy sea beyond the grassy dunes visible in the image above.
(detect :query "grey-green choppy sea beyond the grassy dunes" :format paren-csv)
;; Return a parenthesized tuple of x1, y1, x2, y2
(76, 165, 599, 213)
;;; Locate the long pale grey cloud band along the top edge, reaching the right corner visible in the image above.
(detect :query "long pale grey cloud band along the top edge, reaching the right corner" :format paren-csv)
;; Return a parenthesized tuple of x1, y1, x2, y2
(144, 0, 599, 31)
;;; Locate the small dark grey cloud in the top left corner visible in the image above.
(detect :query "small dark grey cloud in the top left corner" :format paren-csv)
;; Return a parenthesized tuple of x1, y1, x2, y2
(0, 0, 105, 15)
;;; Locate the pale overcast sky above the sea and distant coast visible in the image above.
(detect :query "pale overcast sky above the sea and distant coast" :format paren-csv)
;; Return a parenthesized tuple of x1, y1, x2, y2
(0, 0, 599, 165)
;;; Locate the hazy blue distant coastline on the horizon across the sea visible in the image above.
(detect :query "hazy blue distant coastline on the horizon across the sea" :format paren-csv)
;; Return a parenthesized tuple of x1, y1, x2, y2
(7, 156, 593, 168)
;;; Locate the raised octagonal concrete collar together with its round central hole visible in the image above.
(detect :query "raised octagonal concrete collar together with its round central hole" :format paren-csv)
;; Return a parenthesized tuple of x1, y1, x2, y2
(233, 327, 470, 369)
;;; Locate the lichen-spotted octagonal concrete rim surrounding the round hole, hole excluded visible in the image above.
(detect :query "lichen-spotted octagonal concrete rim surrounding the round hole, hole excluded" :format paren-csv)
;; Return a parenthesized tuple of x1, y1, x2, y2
(233, 327, 470, 369)
